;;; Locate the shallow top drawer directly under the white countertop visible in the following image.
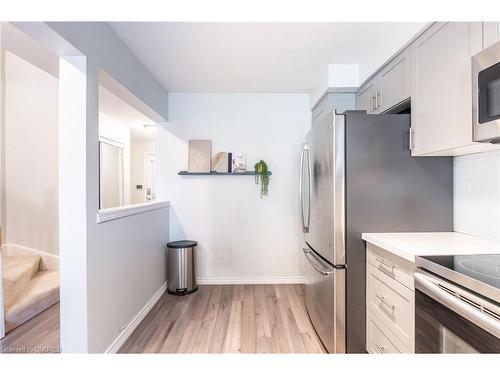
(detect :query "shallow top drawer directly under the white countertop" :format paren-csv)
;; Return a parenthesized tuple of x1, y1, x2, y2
(366, 243, 414, 290)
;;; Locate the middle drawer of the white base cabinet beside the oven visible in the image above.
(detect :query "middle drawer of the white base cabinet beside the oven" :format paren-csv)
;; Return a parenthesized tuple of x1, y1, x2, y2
(366, 264, 415, 349)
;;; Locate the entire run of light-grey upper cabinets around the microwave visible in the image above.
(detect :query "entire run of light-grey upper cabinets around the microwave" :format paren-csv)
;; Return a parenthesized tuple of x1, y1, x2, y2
(356, 22, 500, 156)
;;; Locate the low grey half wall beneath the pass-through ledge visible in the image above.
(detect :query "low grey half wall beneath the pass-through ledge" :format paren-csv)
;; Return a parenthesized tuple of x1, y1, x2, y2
(87, 208, 169, 352)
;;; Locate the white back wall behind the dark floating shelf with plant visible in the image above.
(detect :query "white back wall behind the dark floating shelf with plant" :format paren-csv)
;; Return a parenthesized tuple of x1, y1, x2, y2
(156, 93, 310, 282)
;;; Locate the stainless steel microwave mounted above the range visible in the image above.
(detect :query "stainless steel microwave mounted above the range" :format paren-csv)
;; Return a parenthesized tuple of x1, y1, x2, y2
(472, 42, 500, 143)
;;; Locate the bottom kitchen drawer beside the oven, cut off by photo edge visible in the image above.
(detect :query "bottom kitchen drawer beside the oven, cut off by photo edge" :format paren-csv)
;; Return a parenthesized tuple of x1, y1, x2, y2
(366, 310, 412, 354)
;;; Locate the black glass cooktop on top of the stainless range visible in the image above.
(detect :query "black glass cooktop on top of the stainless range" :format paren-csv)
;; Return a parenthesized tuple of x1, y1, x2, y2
(420, 254, 500, 289)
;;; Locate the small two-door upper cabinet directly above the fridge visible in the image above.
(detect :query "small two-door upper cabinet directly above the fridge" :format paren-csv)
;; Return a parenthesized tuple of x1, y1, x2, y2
(356, 50, 410, 113)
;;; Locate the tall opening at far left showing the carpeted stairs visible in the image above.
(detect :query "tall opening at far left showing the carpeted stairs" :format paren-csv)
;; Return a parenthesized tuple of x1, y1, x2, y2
(0, 23, 59, 352)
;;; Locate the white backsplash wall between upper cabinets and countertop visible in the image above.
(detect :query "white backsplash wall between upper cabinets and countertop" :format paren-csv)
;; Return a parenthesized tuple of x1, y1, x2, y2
(453, 150, 500, 241)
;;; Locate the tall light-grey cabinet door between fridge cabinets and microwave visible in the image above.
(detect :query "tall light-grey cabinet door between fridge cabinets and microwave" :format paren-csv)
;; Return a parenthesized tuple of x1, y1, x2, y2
(411, 22, 473, 155)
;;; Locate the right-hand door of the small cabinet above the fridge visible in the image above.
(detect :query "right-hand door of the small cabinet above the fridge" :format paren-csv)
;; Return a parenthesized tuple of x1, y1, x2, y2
(378, 50, 410, 112)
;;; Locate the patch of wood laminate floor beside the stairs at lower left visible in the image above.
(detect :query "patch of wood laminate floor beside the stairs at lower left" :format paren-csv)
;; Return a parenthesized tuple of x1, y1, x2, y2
(0, 303, 60, 354)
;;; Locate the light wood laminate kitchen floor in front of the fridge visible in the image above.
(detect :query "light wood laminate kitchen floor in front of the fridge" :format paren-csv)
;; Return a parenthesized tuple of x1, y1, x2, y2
(120, 285, 324, 353)
